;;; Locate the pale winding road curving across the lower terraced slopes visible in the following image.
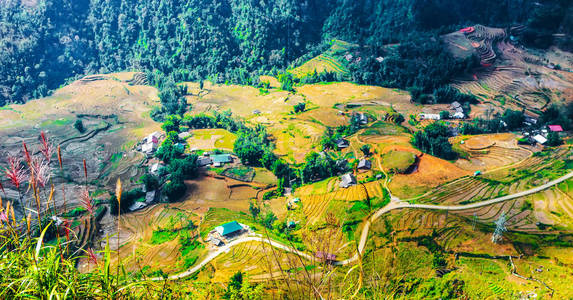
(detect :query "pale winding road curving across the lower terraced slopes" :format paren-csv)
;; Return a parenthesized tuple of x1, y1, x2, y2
(151, 172, 573, 281)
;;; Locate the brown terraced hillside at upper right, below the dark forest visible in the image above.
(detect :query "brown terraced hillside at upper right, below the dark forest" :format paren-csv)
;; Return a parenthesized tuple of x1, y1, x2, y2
(443, 25, 573, 115)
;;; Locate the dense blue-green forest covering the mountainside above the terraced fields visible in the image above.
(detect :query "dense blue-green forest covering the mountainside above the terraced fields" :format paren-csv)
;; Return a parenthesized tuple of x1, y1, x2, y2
(0, 0, 573, 105)
